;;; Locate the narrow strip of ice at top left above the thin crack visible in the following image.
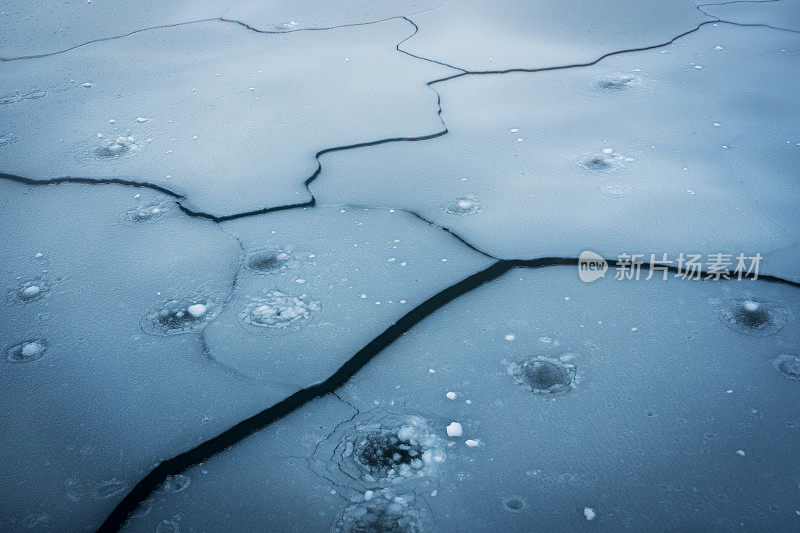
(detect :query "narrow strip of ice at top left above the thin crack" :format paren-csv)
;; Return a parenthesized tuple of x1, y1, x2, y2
(0, 0, 439, 58)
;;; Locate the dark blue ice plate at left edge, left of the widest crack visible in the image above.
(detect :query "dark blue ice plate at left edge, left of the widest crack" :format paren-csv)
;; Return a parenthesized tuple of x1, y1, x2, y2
(0, 181, 294, 531)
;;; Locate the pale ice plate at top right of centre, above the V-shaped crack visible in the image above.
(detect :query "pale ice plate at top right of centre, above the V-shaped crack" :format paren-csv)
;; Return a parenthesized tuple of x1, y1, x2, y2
(403, 0, 709, 71)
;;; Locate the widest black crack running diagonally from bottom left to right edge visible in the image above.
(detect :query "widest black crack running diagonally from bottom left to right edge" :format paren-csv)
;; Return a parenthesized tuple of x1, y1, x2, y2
(98, 257, 800, 532)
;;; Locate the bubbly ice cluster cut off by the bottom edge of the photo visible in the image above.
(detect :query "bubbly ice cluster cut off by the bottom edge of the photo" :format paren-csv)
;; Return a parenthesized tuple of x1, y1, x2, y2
(333, 489, 425, 533)
